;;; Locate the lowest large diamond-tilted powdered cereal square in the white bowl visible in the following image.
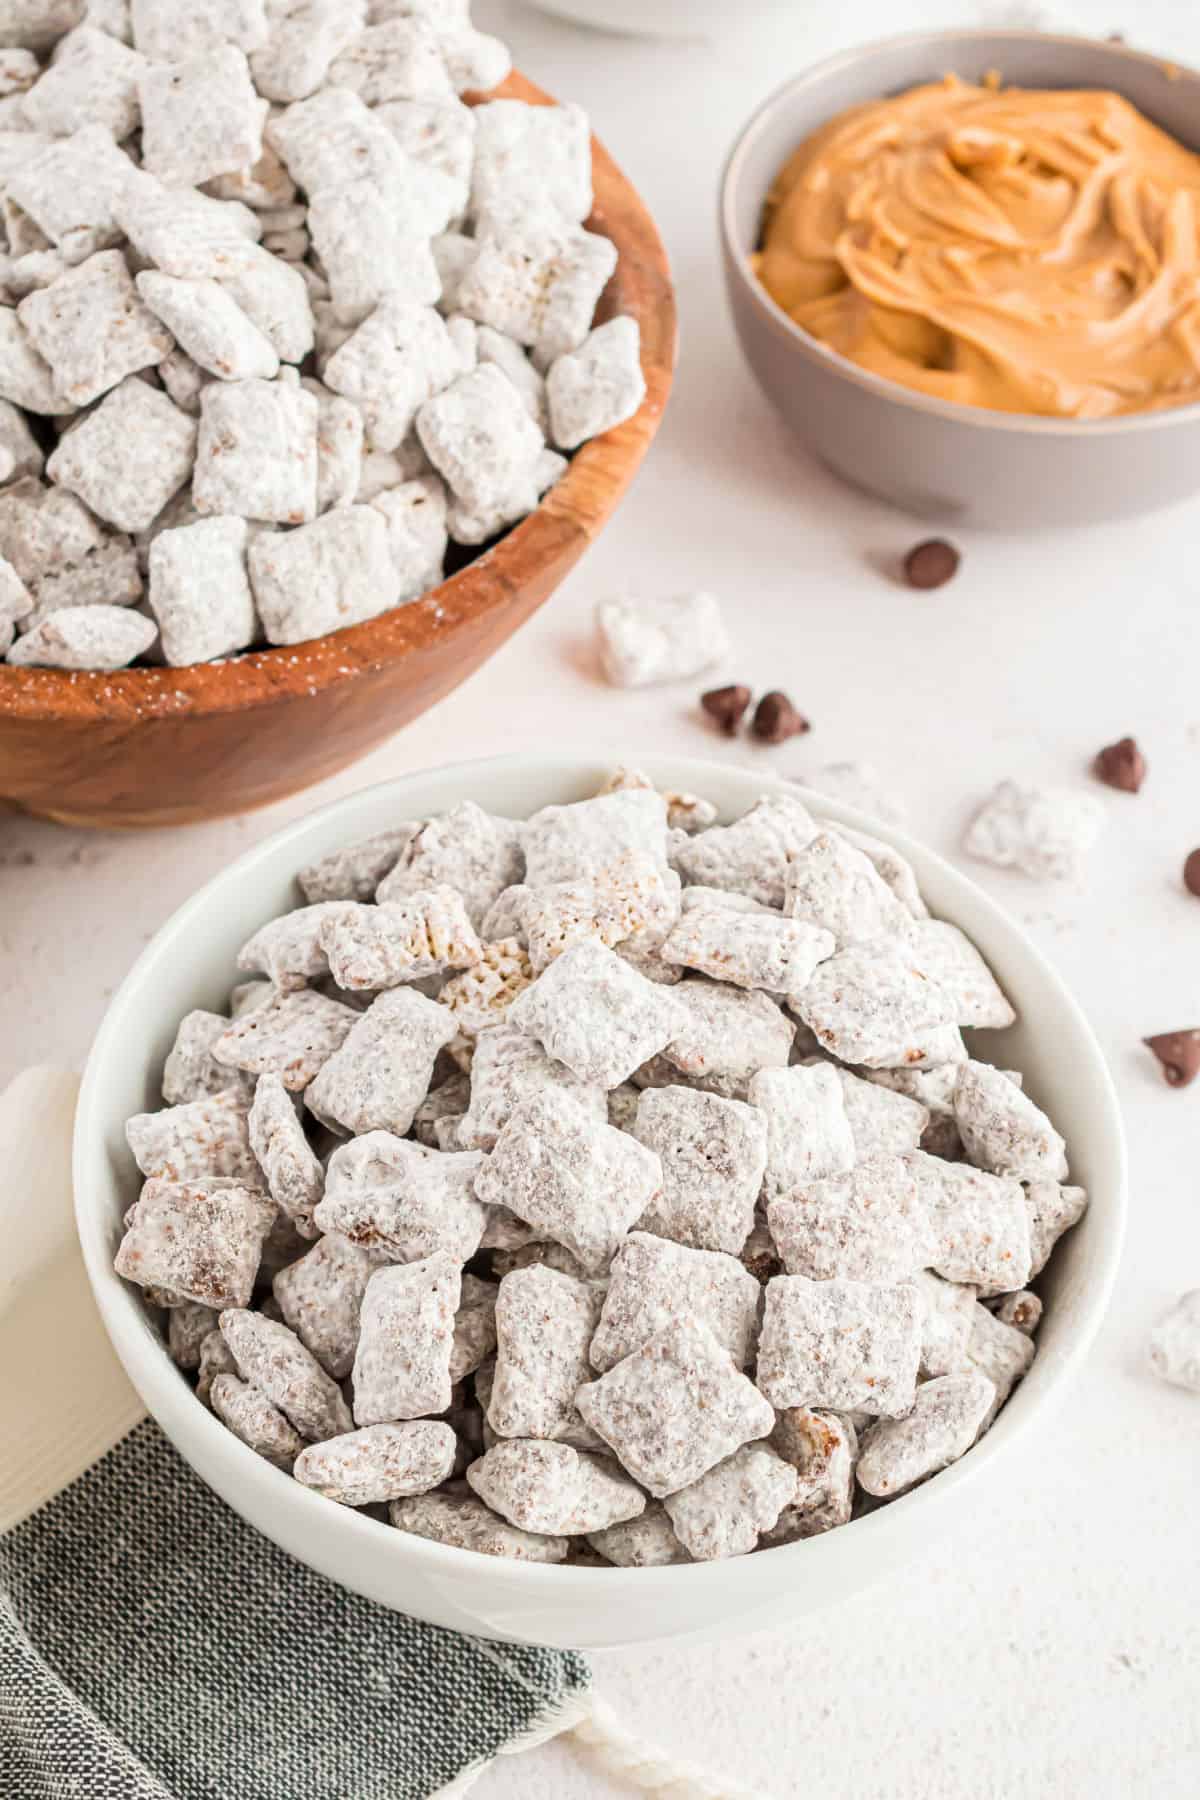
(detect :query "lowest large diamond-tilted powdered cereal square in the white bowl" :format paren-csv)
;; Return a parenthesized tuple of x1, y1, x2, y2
(576, 1319, 774, 1499)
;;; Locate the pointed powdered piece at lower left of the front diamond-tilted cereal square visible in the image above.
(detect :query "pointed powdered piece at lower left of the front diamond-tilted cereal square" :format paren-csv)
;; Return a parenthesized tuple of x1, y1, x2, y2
(466, 1438, 646, 1537)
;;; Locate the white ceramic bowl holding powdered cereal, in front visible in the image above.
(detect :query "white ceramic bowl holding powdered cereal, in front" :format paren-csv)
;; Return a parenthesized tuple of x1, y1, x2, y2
(76, 754, 1124, 1647)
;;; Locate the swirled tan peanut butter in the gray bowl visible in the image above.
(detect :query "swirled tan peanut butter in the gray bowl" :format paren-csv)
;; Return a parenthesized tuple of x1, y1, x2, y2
(754, 76, 1200, 419)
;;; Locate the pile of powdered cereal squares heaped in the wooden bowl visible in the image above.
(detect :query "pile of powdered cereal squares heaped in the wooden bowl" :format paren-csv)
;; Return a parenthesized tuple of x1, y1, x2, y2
(0, 0, 644, 670)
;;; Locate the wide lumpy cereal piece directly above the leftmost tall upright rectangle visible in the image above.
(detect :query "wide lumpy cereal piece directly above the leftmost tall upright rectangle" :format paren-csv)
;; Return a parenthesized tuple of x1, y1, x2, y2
(317, 1130, 486, 1264)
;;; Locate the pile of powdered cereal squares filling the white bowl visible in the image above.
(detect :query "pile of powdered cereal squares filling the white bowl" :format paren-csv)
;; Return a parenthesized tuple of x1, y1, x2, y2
(115, 770, 1087, 1568)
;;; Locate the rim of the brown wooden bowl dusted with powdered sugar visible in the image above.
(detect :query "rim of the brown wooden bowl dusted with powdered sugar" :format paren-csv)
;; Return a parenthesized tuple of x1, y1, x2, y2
(0, 70, 678, 725)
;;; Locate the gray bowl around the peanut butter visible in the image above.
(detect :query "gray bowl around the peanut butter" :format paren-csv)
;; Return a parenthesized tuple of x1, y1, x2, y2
(721, 31, 1200, 529)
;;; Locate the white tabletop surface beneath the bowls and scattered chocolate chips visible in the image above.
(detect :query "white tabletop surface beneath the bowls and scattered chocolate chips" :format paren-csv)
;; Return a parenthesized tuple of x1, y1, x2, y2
(0, 0, 1200, 1800)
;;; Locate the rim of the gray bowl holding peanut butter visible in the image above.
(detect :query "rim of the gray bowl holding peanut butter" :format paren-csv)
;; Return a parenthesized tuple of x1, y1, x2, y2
(718, 25, 1200, 437)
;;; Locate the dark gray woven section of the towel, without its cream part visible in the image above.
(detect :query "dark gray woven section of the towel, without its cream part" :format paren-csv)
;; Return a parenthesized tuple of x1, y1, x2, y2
(0, 1420, 590, 1800)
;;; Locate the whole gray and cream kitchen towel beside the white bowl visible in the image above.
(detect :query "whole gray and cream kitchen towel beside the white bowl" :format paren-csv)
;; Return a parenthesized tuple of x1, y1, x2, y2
(0, 1069, 596, 1800)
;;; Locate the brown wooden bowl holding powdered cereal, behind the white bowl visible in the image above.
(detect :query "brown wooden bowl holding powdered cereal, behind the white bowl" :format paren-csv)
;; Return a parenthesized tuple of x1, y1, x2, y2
(0, 74, 676, 826)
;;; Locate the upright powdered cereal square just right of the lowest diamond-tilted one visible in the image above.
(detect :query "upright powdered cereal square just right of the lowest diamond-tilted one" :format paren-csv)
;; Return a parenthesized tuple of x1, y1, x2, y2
(757, 1274, 921, 1418)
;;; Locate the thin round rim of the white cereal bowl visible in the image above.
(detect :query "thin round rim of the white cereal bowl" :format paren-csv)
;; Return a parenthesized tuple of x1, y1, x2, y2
(72, 751, 1128, 1604)
